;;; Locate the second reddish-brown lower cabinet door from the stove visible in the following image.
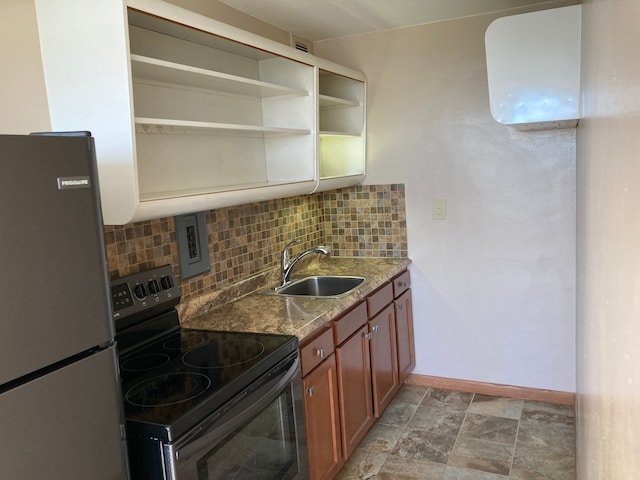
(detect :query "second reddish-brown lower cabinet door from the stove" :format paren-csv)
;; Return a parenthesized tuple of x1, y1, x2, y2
(336, 325, 374, 460)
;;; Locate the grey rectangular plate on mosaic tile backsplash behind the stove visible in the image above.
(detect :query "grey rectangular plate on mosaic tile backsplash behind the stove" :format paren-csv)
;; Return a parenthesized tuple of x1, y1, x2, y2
(174, 212, 211, 280)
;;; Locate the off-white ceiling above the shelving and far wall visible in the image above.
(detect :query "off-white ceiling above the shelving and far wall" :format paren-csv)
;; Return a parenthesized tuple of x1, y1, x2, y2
(220, 0, 553, 42)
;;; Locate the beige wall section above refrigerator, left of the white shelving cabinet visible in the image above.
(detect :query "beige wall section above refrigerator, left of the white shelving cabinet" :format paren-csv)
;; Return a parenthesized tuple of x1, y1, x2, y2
(0, 0, 50, 134)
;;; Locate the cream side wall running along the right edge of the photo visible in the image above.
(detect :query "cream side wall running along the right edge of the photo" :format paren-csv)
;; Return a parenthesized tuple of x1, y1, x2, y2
(577, 0, 640, 480)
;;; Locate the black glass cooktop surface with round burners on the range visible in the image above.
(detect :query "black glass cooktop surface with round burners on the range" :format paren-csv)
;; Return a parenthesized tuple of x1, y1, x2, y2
(119, 329, 298, 441)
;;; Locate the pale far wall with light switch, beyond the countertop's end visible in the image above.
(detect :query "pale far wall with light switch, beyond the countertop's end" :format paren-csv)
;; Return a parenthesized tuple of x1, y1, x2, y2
(314, 5, 575, 391)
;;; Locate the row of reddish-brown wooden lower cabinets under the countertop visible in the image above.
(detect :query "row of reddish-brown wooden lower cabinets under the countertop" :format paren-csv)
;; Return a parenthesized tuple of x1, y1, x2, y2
(301, 271, 415, 480)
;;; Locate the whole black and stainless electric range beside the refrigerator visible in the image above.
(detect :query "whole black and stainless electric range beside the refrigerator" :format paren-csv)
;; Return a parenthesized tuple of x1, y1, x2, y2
(111, 265, 308, 480)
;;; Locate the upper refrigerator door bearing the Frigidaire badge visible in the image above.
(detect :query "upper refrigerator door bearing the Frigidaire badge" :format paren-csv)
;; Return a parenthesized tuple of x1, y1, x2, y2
(0, 135, 114, 385)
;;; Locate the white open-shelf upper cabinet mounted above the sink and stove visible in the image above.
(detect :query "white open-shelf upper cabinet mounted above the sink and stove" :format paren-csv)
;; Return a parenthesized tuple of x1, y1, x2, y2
(36, 0, 365, 224)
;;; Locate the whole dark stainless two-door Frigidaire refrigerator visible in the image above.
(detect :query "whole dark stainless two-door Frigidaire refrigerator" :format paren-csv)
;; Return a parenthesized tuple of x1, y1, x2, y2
(0, 132, 127, 480)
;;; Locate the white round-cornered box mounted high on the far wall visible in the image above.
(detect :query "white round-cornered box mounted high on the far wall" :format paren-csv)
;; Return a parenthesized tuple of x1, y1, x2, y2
(485, 5, 581, 130)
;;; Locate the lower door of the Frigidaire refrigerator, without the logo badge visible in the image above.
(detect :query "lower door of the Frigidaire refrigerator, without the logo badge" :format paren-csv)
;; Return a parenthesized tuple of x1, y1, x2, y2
(0, 347, 127, 480)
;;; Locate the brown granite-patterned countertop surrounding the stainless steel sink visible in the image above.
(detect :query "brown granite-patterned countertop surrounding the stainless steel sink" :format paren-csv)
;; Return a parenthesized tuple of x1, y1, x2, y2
(178, 257, 411, 341)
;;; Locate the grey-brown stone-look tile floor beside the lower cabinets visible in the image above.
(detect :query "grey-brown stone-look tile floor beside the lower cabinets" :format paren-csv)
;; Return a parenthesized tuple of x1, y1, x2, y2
(336, 385, 575, 480)
